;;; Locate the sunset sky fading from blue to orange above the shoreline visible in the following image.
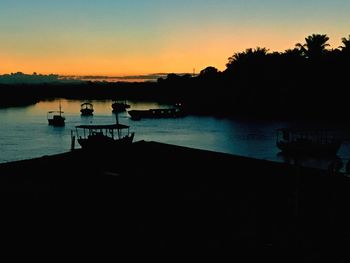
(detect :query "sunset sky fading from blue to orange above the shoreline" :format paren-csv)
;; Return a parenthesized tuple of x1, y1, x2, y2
(0, 0, 350, 76)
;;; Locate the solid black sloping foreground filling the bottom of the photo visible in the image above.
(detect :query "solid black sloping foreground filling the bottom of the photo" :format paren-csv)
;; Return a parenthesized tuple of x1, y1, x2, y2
(0, 142, 350, 262)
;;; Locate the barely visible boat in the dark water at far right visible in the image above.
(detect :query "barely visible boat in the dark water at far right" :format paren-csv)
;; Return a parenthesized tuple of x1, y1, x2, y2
(276, 128, 342, 156)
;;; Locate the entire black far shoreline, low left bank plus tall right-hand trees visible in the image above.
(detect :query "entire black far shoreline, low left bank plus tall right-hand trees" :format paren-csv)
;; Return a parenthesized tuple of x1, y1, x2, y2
(0, 34, 350, 121)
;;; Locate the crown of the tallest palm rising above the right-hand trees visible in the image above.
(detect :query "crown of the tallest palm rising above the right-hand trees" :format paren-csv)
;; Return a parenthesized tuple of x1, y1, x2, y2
(295, 34, 329, 59)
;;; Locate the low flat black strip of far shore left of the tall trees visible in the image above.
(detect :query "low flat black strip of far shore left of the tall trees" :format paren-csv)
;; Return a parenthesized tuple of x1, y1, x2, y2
(0, 82, 156, 107)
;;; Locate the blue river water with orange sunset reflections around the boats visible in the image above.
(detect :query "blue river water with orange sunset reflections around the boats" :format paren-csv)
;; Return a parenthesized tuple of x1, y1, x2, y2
(0, 100, 350, 171)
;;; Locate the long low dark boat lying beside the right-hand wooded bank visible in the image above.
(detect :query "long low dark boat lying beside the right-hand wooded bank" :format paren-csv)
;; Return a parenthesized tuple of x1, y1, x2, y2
(128, 106, 185, 120)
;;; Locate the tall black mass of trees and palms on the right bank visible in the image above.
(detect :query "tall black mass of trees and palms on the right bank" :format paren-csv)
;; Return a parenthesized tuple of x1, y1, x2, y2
(158, 34, 350, 119)
